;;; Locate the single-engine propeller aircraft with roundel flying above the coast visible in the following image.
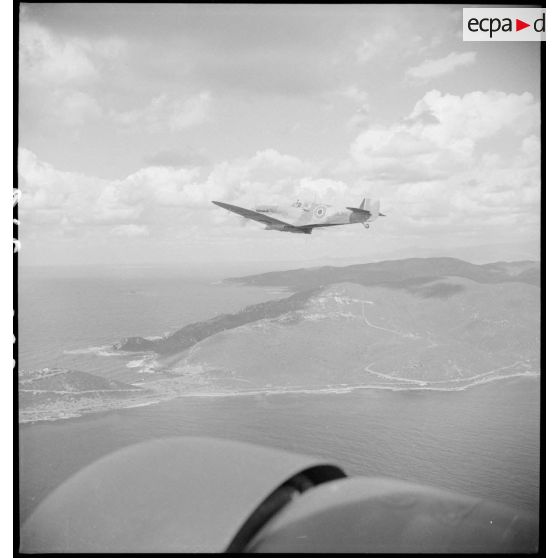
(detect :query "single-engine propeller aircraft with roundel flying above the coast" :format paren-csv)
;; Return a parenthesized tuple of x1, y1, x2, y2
(213, 198, 385, 234)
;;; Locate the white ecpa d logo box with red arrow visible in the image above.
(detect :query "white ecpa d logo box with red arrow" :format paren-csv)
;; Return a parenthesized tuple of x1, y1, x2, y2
(463, 8, 546, 41)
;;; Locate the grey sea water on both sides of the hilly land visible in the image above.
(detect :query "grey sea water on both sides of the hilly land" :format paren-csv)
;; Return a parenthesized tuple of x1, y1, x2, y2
(18, 267, 541, 521)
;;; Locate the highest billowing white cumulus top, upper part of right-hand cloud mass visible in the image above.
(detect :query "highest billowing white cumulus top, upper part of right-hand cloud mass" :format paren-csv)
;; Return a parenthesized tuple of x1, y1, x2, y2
(350, 90, 539, 180)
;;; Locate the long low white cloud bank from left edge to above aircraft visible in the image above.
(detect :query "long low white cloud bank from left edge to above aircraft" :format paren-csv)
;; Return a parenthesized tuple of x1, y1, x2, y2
(18, 148, 328, 236)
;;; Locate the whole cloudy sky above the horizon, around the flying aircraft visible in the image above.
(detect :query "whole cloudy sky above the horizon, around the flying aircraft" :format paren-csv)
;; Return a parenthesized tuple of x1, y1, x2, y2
(19, 4, 540, 265)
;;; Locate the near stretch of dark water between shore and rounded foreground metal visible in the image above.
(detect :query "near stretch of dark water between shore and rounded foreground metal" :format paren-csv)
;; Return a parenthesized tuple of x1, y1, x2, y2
(19, 376, 541, 520)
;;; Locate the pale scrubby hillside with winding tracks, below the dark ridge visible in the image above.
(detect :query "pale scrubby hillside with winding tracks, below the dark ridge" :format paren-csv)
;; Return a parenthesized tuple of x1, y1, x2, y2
(168, 277, 540, 388)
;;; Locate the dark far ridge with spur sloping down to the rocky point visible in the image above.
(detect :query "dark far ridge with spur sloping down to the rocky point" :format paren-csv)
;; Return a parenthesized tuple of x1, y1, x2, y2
(113, 258, 540, 355)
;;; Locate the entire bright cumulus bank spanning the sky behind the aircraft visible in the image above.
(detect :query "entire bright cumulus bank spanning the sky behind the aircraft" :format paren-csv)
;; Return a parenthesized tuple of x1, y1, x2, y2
(19, 84, 540, 266)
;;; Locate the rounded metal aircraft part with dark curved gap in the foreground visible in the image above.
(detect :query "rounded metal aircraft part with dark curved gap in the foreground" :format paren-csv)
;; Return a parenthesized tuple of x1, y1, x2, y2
(20, 438, 538, 553)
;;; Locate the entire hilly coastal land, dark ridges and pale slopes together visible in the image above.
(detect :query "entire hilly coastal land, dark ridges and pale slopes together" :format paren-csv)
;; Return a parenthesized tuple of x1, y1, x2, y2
(19, 258, 540, 422)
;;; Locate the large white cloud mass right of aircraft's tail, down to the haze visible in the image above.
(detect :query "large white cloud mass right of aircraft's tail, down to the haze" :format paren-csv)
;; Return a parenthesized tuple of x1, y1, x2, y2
(351, 91, 540, 234)
